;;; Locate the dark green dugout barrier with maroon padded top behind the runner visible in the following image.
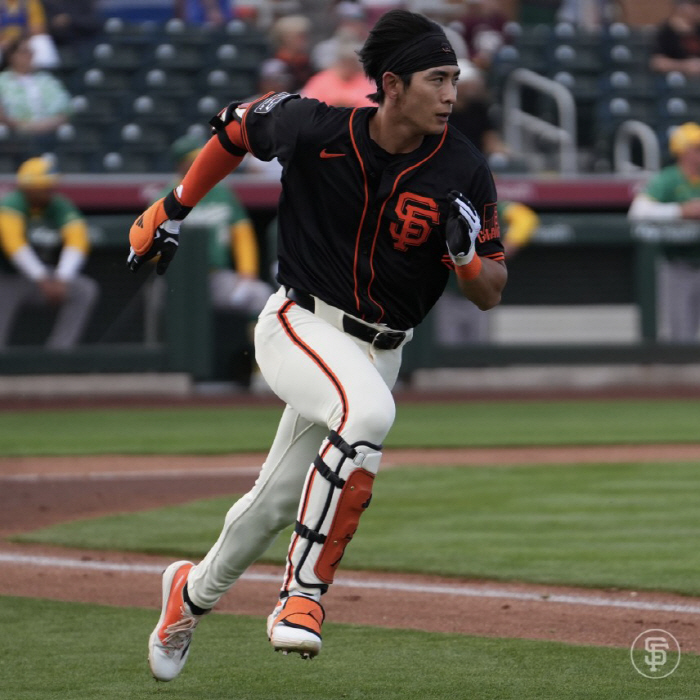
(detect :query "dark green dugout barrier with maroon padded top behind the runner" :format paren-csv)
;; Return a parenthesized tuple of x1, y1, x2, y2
(0, 178, 700, 383)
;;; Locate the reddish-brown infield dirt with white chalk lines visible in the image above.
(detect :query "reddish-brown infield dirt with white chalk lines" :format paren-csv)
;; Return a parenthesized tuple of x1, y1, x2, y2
(0, 445, 700, 653)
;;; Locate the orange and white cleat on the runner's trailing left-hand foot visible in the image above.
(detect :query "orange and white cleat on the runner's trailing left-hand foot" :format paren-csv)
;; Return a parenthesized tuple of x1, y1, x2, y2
(148, 561, 208, 681)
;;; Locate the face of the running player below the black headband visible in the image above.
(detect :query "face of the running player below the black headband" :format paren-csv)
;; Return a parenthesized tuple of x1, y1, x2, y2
(402, 66, 459, 134)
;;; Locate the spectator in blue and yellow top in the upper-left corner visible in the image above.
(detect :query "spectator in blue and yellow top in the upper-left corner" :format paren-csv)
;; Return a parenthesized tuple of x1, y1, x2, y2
(0, 0, 60, 68)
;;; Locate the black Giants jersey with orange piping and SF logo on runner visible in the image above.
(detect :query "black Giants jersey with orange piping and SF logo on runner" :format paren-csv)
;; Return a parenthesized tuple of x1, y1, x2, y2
(227, 93, 504, 330)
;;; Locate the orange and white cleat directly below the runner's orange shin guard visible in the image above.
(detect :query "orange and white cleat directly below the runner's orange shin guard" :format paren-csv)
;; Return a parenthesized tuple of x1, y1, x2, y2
(267, 595, 326, 659)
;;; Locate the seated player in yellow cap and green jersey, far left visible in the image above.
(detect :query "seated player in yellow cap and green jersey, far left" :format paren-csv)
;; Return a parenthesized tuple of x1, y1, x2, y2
(0, 158, 99, 349)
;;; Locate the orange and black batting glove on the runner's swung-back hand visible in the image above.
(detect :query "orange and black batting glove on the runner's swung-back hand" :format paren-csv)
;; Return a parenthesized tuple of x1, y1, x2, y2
(126, 191, 192, 275)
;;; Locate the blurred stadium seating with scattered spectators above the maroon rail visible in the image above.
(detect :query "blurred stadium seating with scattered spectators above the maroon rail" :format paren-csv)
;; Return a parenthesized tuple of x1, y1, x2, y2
(0, 0, 688, 173)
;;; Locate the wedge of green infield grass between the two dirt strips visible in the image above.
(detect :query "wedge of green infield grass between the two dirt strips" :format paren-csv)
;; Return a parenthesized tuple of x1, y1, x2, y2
(17, 463, 700, 595)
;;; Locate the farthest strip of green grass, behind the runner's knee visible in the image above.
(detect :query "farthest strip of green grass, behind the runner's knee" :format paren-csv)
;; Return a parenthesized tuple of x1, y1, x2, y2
(0, 400, 700, 456)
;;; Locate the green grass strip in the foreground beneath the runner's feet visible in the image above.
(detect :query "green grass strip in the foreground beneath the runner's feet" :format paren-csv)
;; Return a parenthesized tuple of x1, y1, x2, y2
(0, 598, 700, 700)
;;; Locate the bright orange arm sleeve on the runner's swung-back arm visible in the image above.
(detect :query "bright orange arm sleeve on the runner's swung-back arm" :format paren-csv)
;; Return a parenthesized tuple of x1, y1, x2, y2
(175, 122, 246, 207)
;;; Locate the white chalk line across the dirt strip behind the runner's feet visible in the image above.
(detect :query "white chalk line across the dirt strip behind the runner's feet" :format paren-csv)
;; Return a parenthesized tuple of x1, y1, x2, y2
(5, 552, 700, 615)
